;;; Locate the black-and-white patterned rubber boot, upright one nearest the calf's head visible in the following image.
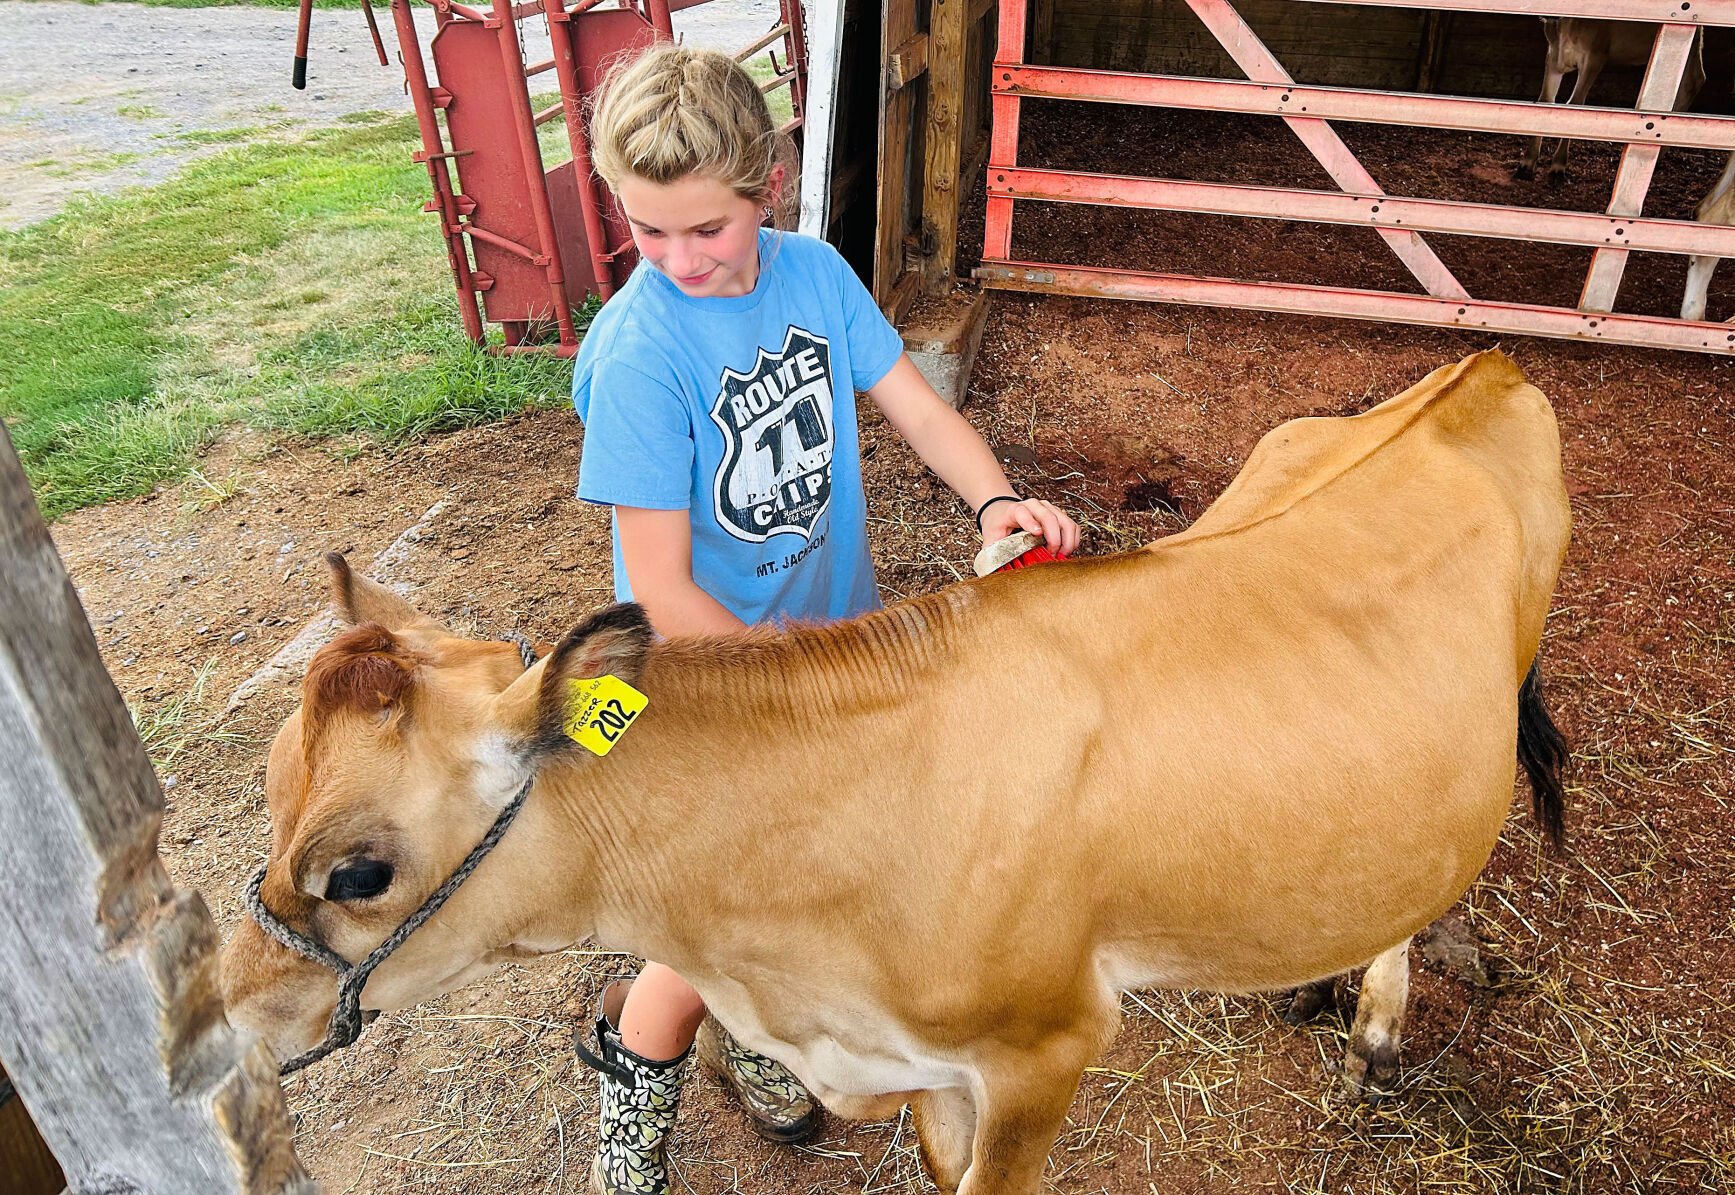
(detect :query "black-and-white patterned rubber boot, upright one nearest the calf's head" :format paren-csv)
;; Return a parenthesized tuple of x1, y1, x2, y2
(573, 980, 692, 1195)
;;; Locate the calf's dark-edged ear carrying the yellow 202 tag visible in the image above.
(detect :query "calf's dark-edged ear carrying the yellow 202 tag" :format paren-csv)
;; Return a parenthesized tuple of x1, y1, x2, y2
(494, 602, 656, 754)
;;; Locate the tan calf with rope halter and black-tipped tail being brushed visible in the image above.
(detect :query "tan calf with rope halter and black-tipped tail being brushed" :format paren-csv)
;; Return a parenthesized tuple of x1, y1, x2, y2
(224, 354, 1568, 1195)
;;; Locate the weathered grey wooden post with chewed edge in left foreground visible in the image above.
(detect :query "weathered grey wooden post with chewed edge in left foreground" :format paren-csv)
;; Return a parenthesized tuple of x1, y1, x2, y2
(0, 430, 318, 1195)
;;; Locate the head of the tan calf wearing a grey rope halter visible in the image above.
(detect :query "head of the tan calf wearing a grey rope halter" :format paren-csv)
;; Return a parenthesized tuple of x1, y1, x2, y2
(222, 555, 651, 1058)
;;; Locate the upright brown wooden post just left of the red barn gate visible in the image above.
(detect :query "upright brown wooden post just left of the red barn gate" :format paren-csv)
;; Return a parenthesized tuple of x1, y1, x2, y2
(921, 0, 973, 295)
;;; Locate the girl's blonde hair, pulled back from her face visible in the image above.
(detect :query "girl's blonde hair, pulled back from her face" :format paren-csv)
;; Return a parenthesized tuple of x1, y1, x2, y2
(590, 43, 779, 203)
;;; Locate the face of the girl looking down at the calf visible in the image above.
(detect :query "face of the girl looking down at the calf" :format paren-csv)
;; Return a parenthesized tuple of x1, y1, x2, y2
(618, 172, 781, 298)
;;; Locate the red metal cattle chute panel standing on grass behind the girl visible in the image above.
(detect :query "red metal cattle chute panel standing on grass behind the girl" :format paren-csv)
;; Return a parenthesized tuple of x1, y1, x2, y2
(392, 0, 807, 356)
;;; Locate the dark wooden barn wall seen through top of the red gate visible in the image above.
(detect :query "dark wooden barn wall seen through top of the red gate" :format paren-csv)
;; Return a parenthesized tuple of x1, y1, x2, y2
(1031, 0, 1544, 99)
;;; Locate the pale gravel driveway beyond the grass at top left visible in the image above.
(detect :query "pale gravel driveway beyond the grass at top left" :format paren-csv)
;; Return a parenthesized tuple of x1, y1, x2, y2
(0, 0, 777, 229)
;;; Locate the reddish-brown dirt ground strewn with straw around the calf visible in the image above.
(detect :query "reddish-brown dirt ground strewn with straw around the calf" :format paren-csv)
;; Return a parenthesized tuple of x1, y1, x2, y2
(40, 100, 1735, 1195)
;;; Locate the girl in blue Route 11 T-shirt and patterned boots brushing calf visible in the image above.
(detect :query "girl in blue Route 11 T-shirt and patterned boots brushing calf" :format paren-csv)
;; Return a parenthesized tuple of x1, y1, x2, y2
(573, 45, 1079, 1195)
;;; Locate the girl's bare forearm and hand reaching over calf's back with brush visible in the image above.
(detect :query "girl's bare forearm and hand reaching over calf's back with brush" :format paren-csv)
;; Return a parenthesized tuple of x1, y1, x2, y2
(874, 352, 1079, 558)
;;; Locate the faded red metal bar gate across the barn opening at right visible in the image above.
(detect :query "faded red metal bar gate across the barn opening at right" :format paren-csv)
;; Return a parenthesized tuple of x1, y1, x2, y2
(977, 0, 1735, 354)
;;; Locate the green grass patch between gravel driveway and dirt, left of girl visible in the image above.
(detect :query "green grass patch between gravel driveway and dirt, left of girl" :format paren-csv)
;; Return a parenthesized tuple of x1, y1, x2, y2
(0, 118, 571, 519)
